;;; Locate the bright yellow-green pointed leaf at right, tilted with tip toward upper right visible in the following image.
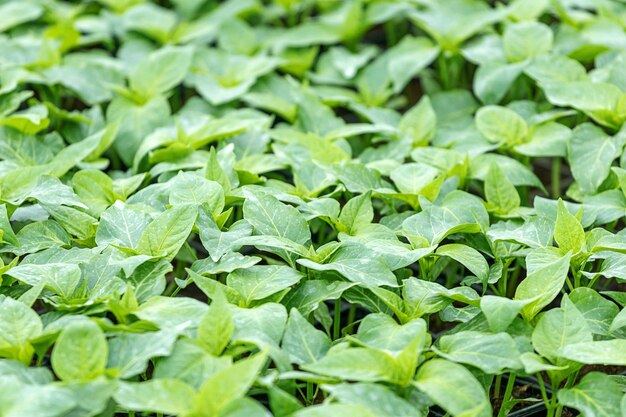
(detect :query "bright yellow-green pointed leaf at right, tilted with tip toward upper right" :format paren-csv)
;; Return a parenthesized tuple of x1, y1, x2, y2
(514, 249, 571, 320)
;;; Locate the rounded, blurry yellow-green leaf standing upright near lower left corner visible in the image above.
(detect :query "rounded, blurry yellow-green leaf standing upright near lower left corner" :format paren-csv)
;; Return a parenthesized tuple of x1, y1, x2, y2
(51, 320, 109, 381)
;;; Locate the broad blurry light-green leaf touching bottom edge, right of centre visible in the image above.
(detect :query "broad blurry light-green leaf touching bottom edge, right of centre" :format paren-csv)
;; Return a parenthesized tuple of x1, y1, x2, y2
(413, 359, 491, 417)
